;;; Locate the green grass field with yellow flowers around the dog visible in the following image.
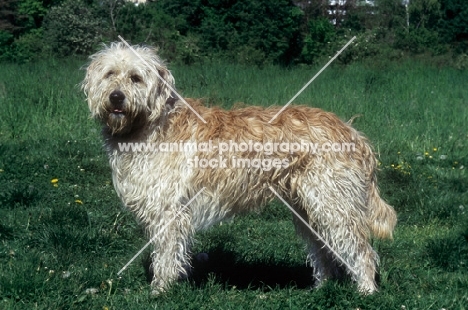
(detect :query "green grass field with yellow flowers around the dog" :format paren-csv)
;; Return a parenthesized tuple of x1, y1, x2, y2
(0, 60, 468, 309)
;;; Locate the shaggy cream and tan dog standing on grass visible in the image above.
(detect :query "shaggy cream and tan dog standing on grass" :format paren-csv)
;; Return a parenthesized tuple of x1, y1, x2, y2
(82, 43, 396, 294)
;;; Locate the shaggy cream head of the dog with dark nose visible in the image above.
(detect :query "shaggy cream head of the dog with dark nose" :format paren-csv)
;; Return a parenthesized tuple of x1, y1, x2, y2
(82, 43, 174, 135)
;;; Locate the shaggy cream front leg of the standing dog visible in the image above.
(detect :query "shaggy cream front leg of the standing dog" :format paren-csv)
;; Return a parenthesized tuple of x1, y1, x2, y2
(147, 205, 194, 294)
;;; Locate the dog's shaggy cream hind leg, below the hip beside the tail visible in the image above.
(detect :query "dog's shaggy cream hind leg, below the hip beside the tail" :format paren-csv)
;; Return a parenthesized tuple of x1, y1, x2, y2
(298, 170, 378, 294)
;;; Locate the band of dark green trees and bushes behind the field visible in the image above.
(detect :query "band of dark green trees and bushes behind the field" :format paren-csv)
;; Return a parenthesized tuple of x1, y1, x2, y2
(0, 0, 468, 65)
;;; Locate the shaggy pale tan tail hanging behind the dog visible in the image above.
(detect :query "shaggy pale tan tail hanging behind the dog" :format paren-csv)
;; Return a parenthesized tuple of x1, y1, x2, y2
(368, 178, 397, 239)
